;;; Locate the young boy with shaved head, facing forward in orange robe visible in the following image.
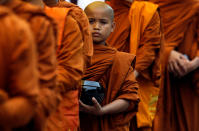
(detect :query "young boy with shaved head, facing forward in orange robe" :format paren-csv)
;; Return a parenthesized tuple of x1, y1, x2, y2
(80, 2, 139, 131)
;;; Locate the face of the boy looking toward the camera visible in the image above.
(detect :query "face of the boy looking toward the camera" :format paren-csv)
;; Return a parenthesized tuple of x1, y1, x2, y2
(87, 7, 114, 44)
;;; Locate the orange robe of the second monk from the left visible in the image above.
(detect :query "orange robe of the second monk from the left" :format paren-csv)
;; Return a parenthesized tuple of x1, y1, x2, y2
(5, 0, 60, 130)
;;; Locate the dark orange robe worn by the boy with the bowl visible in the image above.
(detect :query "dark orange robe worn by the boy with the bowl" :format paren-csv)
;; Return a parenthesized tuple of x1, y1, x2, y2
(80, 45, 139, 131)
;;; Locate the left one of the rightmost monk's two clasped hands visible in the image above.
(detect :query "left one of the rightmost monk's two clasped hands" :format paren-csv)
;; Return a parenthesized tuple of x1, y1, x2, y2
(168, 50, 189, 77)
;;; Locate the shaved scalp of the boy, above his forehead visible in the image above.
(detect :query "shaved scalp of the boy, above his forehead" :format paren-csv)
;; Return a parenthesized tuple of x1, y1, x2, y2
(84, 1, 114, 21)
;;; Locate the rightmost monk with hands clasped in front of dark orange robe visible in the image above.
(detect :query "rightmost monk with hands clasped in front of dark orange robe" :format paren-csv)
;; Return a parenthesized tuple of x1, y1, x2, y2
(137, 0, 199, 131)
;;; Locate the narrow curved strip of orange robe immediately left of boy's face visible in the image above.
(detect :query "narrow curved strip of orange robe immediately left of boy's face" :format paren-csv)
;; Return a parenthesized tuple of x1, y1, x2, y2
(57, 1, 93, 66)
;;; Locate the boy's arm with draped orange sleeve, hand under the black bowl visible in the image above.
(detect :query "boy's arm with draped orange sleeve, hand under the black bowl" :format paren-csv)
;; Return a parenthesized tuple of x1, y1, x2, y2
(80, 67, 139, 115)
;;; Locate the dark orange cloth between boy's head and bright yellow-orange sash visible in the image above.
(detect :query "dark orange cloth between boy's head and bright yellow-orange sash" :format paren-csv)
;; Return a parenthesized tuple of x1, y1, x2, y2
(107, 0, 131, 52)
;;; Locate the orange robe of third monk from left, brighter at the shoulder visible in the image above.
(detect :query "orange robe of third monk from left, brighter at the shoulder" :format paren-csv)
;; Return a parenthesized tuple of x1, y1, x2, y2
(45, 6, 84, 131)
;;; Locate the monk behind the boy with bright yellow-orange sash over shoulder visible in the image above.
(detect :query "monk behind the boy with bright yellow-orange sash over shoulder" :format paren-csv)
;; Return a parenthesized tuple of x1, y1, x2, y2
(107, 0, 163, 131)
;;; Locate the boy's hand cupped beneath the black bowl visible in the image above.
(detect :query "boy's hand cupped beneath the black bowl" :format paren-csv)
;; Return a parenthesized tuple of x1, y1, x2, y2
(79, 97, 104, 116)
